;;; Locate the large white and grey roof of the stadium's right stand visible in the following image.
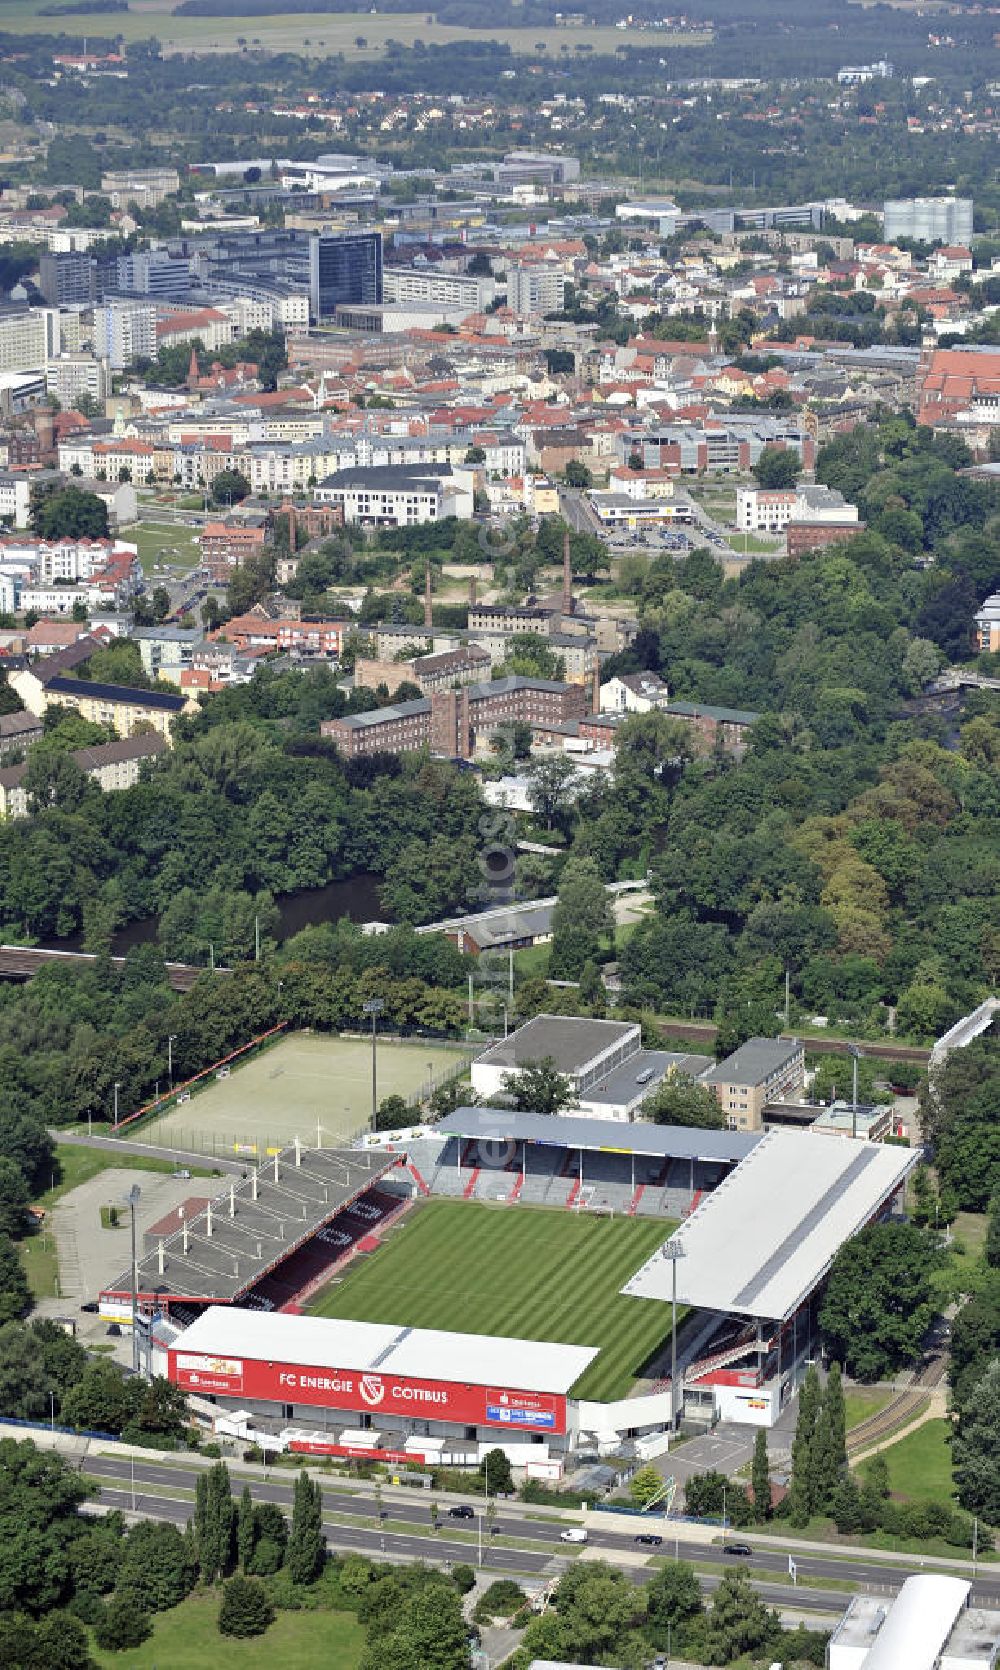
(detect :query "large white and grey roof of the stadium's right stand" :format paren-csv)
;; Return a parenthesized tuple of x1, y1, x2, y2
(623, 1127, 920, 1321)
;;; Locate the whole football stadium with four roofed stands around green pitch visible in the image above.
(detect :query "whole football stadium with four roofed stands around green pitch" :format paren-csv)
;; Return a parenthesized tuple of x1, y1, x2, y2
(100, 1107, 918, 1478)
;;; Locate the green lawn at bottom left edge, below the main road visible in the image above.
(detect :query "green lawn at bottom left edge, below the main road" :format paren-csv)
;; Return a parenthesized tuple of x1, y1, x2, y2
(90, 1595, 366, 1670)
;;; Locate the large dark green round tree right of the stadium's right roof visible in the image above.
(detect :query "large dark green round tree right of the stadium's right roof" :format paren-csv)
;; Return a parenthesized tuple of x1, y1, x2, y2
(820, 1222, 942, 1381)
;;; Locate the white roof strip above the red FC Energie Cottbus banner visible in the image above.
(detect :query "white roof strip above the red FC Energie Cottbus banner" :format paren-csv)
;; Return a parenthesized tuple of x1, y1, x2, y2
(175, 1306, 598, 1393)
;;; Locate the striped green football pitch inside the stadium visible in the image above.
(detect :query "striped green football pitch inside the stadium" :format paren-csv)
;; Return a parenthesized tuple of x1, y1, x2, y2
(311, 1201, 676, 1401)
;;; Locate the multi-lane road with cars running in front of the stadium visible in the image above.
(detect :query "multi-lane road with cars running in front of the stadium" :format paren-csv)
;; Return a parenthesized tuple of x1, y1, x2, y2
(82, 1455, 1000, 1615)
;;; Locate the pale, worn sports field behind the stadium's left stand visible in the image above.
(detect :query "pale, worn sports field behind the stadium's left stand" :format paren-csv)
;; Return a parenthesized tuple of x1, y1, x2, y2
(135, 1034, 469, 1154)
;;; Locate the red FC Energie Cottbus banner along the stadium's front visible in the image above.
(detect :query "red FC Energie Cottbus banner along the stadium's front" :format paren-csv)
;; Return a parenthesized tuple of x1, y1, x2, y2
(170, 1351, 566, 1433)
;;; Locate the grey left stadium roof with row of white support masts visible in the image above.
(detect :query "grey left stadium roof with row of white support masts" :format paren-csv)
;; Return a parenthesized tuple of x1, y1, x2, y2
(104, 1144, 397, 1304)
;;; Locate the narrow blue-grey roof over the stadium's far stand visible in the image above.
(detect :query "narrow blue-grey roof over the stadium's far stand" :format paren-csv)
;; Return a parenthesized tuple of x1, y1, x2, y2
(434, 1107, 757, 1166)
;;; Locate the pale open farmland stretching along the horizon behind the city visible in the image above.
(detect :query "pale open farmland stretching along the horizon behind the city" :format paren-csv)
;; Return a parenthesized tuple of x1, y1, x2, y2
(0, 0, 711, 60)
